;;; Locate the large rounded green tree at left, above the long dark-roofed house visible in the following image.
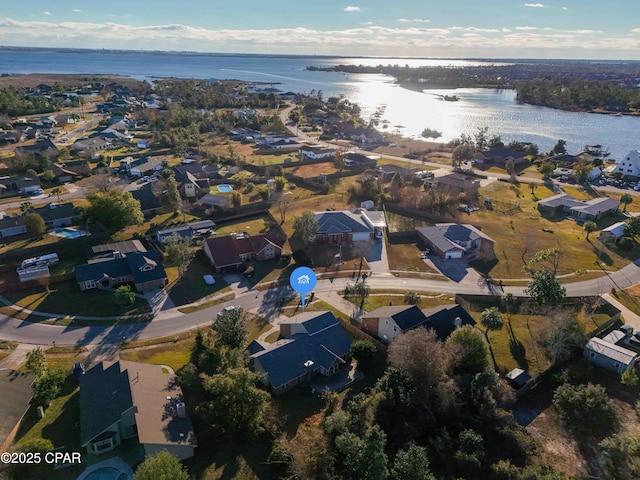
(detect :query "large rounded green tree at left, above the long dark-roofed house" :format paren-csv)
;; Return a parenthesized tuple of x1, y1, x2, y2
(87, 189, 144, 233)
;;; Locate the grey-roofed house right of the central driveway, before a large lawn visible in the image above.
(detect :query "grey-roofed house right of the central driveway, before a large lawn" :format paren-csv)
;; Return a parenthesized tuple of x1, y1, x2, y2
(416, 223, 495, 261)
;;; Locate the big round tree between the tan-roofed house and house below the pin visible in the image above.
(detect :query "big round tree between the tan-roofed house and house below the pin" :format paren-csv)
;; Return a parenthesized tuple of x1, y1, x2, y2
(196, 367, 269, 440)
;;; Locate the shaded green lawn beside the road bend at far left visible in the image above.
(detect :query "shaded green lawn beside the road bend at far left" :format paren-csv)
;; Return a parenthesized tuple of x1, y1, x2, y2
(4, 280, 150, 322)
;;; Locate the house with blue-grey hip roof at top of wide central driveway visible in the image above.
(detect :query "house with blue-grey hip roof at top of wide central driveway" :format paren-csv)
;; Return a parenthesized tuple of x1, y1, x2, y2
(313, 209, 386, 243)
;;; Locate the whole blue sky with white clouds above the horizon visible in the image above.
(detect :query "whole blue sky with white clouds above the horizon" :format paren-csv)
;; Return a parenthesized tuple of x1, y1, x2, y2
(0, 0, 640, 60)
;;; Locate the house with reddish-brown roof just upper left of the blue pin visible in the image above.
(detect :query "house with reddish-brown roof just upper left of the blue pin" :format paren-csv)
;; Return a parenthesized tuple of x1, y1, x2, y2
(202, 233, 282, 273)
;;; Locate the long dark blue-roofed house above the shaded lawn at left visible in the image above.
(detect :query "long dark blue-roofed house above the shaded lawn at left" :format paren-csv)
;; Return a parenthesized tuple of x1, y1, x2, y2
(74, 250, 167, 292)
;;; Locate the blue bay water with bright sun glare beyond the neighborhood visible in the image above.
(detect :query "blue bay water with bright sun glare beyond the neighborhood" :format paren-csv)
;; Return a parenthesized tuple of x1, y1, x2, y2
(0, 49, 640, 160)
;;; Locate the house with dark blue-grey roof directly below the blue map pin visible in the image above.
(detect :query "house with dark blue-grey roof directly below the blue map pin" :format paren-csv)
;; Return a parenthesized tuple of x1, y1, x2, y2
(248, 312, 351, 394)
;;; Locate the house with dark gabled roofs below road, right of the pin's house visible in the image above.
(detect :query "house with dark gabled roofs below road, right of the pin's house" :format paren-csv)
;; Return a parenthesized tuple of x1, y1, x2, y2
(361, 305, 476, 343)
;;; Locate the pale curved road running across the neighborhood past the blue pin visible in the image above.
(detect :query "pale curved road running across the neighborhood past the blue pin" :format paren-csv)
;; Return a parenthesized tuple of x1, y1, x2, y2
(0, 261, 640, 345)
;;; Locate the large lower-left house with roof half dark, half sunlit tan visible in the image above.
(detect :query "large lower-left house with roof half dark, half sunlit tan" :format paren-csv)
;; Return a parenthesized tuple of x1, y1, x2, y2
(80, 361, 197, 460)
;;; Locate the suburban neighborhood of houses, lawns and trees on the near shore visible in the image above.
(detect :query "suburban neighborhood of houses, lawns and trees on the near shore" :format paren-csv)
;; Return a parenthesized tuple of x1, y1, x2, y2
(0, 63, 640, 480)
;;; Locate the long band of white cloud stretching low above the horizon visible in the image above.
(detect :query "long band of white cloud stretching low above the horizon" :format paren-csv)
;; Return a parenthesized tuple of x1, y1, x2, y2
(0, 17, 640, 59)
